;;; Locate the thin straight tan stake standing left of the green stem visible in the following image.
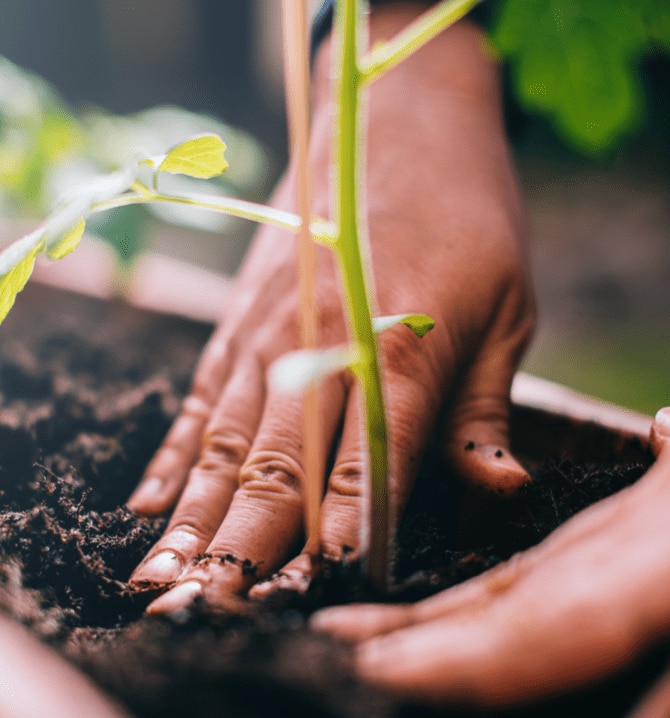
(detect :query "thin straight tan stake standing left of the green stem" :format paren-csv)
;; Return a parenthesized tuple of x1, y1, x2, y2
(282, 0, 323, 561)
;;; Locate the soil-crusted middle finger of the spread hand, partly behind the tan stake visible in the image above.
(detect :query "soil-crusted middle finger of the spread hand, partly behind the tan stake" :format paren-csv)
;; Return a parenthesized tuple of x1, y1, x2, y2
(147, 377, 345, 613)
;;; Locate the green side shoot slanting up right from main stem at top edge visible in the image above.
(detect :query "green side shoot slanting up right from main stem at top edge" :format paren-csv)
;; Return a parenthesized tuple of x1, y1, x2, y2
(361, 0, 481, 85)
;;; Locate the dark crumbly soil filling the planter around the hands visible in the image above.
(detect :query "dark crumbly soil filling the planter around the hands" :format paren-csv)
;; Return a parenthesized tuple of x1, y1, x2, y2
(0, 287, 666, 718)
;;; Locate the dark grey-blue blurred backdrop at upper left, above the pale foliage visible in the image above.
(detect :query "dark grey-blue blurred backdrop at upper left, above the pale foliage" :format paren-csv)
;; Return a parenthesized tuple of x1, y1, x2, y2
(0, 0, 286, 162)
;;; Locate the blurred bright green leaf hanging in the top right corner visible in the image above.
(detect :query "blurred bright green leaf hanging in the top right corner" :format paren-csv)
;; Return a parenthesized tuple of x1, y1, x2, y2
(492, 0, 670, 153)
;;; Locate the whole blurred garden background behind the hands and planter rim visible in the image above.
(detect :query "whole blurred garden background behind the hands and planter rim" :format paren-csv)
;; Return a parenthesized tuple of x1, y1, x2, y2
(0, 0, 670, 412)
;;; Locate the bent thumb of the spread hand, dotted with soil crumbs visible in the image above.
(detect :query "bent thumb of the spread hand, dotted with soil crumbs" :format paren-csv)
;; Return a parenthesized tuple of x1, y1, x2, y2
(446, 286, 532, 493)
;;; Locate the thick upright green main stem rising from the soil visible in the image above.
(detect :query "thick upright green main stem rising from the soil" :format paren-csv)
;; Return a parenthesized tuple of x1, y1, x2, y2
(334, 0, 389, 587)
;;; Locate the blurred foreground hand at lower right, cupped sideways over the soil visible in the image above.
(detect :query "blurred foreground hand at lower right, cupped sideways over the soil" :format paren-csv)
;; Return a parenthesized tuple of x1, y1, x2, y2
(313, 409, 670, 718)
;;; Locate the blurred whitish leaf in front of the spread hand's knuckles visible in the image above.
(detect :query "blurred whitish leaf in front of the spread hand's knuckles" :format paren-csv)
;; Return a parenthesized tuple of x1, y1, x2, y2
(269, 346, 360, 394)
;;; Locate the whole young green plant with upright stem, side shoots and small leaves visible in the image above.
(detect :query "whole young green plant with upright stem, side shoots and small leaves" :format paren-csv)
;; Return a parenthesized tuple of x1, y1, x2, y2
(0, 0, 479, 585)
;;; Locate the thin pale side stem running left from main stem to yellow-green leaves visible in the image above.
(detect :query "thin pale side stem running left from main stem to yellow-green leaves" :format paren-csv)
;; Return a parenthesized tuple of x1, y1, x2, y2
(90, 190, 335, 246)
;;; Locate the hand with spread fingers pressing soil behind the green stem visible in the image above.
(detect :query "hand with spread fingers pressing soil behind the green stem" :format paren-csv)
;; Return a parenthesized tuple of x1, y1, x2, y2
(124, 3, 533, 612)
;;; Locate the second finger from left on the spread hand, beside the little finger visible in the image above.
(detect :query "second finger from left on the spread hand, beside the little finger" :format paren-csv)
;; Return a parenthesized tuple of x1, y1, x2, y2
(130, 356, 263, 587)
